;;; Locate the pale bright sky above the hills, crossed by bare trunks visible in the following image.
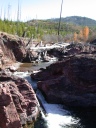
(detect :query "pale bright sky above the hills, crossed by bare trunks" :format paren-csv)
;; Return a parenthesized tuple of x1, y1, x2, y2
(0, 0, 96, 21)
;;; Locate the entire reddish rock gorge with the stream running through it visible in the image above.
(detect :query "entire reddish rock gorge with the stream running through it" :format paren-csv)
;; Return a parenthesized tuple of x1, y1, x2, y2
(0, 33, 96, 128)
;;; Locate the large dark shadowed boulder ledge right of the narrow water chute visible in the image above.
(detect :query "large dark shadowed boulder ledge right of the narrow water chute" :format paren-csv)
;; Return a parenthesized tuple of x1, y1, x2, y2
(31, 53, 96, 107)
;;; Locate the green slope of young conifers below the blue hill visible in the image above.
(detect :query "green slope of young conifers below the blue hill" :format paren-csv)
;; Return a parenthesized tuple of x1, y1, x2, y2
(0, 20, 81, 38)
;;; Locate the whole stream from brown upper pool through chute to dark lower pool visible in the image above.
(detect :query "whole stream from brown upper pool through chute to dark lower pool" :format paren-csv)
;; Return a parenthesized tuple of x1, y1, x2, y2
(14, 62, 96, 128)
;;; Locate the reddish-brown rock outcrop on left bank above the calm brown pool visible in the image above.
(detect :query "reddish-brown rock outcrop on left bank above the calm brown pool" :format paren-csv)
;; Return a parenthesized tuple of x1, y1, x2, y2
(0, 33, 26, 68)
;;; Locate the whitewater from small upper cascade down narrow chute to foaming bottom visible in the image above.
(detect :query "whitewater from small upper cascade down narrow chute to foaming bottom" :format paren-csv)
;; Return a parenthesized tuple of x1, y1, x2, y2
(14, 72, 79, 128)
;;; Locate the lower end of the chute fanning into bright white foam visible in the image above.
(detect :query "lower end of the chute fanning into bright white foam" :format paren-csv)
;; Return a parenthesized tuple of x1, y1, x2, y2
(36, 91, 79, 128)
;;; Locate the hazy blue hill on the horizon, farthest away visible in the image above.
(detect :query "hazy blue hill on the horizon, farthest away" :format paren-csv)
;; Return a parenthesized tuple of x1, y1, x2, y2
(48, 16, 96, 26)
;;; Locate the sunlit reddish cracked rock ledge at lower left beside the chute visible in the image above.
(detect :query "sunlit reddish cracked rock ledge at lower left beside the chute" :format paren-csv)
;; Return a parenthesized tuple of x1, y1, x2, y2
(0, 70, 40, 128)
